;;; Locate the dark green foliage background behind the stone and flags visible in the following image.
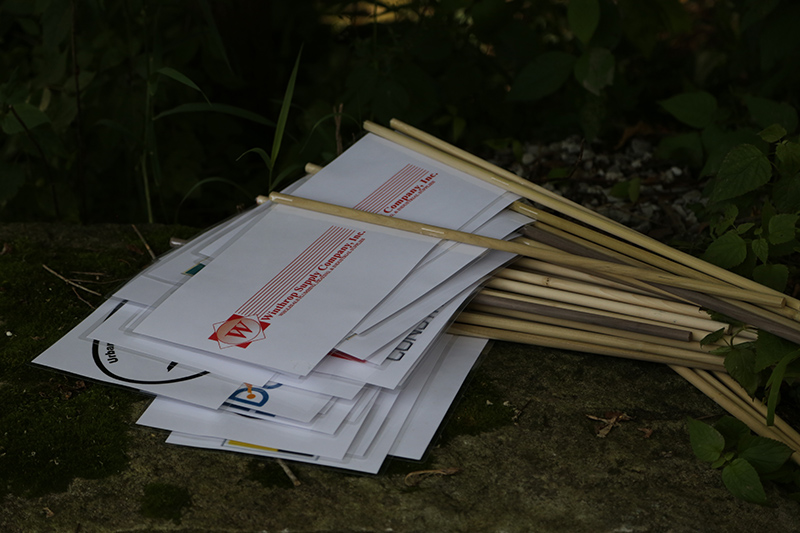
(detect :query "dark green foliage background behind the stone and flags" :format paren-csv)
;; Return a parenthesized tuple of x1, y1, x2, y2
(0, 0, 800, 274)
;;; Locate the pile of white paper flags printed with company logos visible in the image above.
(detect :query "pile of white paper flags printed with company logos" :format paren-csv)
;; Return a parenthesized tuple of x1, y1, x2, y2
(34, 134, 530, 473)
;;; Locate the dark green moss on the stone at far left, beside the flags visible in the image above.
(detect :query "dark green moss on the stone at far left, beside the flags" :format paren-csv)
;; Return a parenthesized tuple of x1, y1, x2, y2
(0, 225, 197, 496)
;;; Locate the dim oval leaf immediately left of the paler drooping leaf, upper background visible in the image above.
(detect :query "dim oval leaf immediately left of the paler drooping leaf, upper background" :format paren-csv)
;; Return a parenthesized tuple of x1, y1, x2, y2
(508, 52, 575, 102)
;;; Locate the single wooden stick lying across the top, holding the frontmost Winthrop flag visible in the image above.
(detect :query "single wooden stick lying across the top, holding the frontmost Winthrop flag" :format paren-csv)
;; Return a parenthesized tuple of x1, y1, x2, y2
(269, 192, 784, 307)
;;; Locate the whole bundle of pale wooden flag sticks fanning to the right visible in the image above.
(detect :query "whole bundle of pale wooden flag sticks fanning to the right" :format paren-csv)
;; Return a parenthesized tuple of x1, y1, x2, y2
(270, 120, 800, 464)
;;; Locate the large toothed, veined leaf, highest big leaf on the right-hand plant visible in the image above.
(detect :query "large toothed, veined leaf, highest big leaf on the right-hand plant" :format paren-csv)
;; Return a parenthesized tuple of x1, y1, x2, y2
(710, 144, 772, 202)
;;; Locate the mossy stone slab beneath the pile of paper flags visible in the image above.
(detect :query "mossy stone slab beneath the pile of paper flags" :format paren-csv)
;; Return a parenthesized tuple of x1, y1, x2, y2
(0, 225, 800, 533)
